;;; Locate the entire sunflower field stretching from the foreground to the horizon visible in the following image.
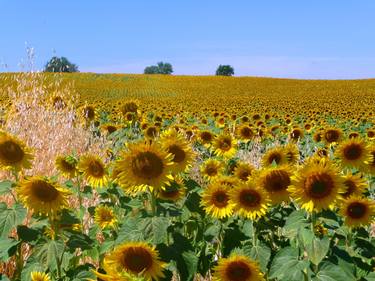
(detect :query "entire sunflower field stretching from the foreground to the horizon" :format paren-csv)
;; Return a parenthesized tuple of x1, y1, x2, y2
(0, 72, 375, 281)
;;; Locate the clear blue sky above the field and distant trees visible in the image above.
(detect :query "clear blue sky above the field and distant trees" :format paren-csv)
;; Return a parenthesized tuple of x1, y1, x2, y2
(0, 0, 375, 79)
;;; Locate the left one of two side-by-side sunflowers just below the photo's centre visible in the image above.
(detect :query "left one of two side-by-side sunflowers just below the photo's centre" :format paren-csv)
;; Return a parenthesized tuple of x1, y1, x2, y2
(201, 181, 233, 219)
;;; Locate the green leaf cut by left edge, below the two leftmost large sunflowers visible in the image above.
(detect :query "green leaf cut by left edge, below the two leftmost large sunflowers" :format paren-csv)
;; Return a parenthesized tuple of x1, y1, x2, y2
(0, 203, 26, 239)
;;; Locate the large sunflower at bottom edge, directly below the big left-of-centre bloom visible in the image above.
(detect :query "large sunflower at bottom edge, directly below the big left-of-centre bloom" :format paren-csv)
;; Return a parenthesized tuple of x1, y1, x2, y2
(104, 242, 166, 281)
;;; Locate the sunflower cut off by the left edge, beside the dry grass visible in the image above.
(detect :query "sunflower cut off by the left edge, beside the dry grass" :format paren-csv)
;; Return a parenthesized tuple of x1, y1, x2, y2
(0, 132, 34, 170)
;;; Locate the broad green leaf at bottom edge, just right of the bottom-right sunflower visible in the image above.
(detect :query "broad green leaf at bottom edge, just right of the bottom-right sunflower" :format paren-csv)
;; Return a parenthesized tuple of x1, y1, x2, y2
(269, 247, 309, 281)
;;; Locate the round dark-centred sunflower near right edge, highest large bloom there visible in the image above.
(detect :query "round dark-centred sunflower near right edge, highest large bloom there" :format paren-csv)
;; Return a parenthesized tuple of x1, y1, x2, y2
(335, 138, 370, 169)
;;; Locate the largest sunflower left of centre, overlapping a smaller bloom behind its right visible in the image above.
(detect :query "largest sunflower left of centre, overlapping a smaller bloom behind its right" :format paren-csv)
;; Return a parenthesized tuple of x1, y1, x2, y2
(114, 142, 173, 193)
